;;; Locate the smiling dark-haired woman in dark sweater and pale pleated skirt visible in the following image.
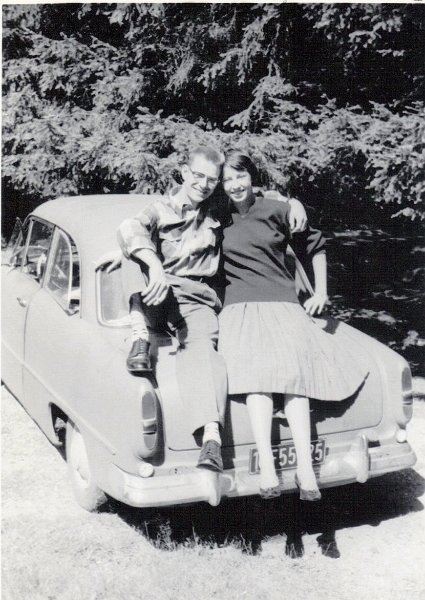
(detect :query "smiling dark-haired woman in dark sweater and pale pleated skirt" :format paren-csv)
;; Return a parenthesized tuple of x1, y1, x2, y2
(219, 153, 367, 500)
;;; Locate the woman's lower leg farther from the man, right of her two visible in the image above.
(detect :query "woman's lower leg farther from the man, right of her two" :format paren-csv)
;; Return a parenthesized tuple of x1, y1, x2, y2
(285, 394, 318, 490)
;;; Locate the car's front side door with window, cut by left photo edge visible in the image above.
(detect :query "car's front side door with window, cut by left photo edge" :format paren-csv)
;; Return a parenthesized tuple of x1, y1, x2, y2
(2, 217, 53, 401)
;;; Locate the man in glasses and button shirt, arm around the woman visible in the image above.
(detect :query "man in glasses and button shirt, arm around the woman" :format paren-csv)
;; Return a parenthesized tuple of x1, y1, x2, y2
(118, 146, 305, 472)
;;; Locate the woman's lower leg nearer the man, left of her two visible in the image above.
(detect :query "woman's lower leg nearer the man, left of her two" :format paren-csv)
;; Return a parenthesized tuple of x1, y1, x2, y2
(246, 394, 279, 489)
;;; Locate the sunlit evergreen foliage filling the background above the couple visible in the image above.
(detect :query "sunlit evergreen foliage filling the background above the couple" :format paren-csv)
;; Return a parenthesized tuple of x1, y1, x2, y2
(3, 3, 425, 222)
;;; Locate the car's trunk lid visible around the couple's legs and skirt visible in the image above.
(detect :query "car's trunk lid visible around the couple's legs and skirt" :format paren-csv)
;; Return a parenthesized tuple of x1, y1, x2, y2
(153, 319, 383, 450)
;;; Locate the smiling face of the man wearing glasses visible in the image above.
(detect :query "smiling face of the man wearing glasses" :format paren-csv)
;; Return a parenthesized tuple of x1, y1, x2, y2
(182, 156, 221, 207)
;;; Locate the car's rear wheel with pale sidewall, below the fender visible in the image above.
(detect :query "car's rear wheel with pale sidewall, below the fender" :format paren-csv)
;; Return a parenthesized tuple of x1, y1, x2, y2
(65, 420, 107, 512)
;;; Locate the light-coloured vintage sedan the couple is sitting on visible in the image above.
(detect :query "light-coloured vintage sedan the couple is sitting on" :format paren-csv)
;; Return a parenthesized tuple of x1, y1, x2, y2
(2, 194, 416, 510)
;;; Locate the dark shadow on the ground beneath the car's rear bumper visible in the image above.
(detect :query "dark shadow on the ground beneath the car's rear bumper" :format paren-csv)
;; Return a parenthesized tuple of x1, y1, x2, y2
(108, 469, 425, 558)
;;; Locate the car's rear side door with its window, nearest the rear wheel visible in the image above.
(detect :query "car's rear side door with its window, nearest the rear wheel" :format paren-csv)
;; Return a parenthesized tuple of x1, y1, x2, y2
(23, 228, 83, 441)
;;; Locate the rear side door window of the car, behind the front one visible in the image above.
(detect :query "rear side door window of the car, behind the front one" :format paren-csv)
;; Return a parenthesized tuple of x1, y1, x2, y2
(45, 229, 80, 312)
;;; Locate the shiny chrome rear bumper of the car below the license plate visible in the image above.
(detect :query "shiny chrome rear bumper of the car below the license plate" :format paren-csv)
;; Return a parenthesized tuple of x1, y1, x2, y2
(109, 435, 416, 508)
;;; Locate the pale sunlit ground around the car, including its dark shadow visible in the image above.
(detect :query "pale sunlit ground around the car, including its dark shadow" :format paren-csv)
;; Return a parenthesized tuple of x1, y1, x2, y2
(2, 389, 425, 600)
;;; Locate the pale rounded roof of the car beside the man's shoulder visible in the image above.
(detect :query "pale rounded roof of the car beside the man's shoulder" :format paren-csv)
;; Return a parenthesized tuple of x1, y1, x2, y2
(32, 194, 161, 260)
